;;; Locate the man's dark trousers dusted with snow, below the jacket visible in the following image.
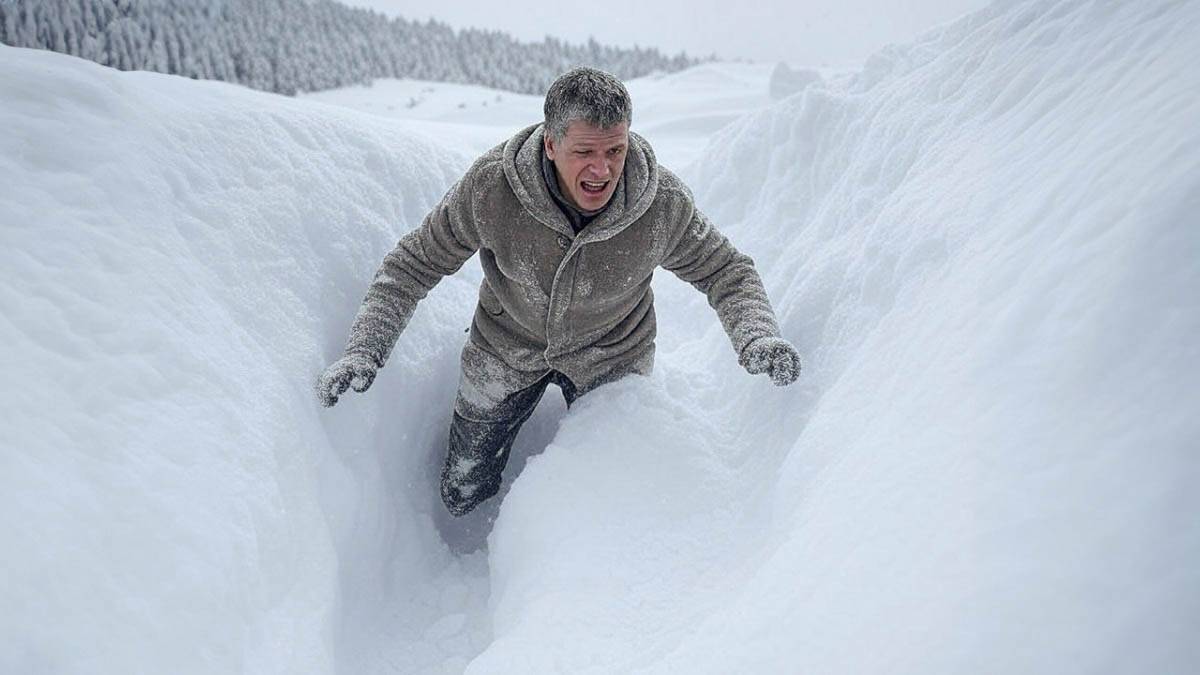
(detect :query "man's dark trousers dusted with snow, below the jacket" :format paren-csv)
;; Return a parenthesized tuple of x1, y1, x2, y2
(442, 370, 580, 515)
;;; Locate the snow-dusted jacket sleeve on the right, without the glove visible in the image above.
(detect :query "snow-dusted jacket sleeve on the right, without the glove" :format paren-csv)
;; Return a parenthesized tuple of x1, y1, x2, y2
(662, 198, 780, 357)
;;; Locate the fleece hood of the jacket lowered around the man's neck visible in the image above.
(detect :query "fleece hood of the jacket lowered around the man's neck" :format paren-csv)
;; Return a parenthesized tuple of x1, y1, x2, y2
(503, 124, 659, 241)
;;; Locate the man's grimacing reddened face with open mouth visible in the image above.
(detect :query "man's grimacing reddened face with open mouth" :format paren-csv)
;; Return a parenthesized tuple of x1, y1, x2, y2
(545, 120, 629, 211)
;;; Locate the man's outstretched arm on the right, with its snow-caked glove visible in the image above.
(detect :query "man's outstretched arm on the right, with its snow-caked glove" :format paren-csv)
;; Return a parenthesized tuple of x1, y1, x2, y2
(662, 200, 800, 386)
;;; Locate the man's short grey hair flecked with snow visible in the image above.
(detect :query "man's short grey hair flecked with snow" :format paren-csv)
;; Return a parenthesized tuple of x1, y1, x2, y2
(542, 67, 634, 141)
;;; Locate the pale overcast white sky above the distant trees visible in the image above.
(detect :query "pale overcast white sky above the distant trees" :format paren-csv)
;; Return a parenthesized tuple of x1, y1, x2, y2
(342, 0, 988, 66)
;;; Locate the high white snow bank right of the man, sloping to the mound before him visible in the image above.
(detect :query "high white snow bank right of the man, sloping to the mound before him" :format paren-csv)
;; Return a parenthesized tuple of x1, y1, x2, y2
(468, 1, 1200, 673)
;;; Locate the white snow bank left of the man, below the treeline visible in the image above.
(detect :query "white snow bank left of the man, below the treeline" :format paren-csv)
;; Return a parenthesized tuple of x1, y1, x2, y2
(0, 47, 486, 673)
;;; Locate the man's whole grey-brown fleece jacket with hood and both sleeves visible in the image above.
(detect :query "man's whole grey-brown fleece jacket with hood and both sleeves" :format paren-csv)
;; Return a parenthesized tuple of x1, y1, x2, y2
(346, 124, 779, 393)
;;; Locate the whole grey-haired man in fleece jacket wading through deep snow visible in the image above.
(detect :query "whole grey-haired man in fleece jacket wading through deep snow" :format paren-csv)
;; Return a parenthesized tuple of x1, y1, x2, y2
(318, 68, 800, 515)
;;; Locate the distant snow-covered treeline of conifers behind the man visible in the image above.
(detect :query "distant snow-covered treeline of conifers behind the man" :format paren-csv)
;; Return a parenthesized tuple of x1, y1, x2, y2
(0, 0, 697, 95)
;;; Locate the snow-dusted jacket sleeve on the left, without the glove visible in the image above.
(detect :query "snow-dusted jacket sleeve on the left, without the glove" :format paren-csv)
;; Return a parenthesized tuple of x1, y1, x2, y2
(344, 172, 479, 368)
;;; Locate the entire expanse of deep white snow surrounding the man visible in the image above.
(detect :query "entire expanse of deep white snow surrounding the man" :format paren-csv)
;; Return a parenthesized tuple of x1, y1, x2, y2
(0, 0, 1200, 674)
